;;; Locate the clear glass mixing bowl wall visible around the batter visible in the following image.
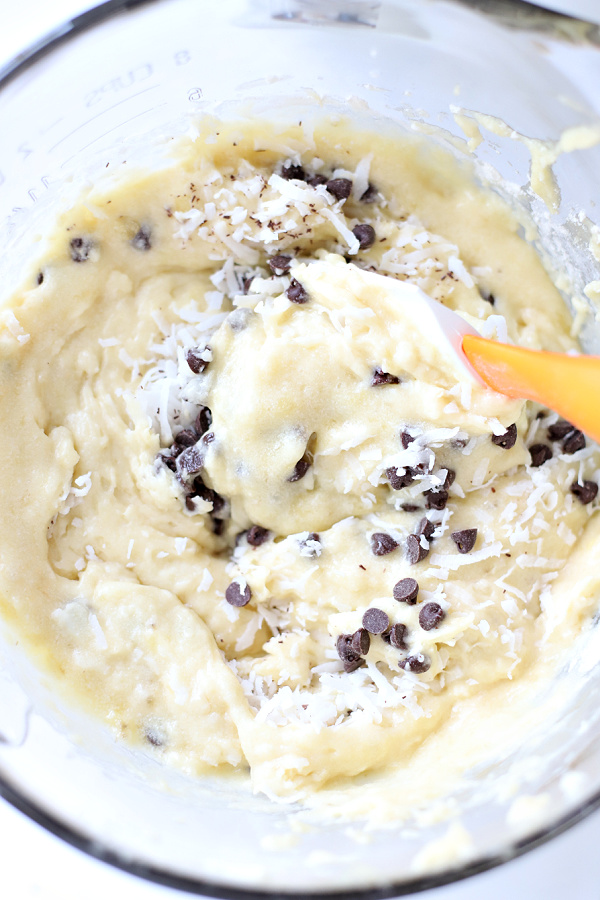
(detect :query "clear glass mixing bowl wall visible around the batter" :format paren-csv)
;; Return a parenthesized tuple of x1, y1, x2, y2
(0, 0, 600, 900)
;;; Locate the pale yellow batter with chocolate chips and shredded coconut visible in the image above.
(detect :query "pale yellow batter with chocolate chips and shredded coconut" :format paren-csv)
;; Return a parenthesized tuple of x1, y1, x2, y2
(0, 120, 600, 818)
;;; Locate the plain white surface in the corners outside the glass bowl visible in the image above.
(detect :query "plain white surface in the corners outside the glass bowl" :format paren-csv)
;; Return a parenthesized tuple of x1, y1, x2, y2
(0, 0, 600, 900)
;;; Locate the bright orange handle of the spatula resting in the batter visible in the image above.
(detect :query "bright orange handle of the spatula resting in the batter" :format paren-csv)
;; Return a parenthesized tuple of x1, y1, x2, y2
(462, 334, 600, 441)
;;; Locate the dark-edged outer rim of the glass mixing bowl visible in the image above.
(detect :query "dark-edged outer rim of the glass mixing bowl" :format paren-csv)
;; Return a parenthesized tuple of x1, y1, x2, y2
(0, 0, 600, 900)
